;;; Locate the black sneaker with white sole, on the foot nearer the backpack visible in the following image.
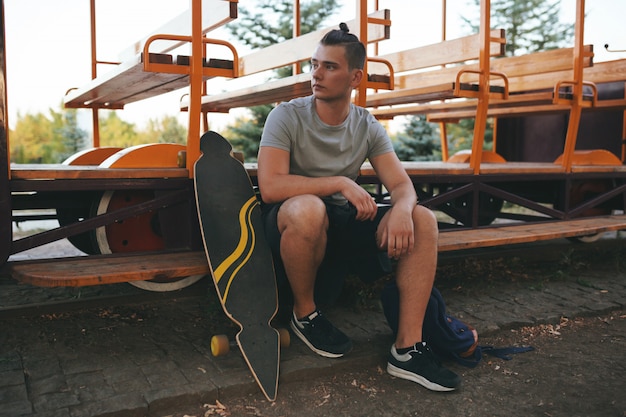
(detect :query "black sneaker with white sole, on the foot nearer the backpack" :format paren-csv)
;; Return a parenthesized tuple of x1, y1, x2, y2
(387, 342, 461, 391)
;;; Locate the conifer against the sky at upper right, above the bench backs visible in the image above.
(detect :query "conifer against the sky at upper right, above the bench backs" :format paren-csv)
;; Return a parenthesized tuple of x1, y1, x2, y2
(463, 0, 574, 55)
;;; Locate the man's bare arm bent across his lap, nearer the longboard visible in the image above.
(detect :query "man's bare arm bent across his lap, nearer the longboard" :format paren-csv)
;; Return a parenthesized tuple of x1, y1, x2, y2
(257, 146, 376, 220)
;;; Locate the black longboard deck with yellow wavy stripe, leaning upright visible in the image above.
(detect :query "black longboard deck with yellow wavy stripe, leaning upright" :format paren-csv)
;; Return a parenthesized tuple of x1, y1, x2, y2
(194, 132, 280, 401)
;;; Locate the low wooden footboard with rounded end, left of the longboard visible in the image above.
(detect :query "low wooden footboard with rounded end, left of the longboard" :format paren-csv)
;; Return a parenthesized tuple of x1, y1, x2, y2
(7, 251, 210, 287)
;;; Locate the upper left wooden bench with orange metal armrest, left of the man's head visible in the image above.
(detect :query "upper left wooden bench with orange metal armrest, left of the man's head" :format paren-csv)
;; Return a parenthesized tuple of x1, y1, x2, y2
(64, 0, 237, 109)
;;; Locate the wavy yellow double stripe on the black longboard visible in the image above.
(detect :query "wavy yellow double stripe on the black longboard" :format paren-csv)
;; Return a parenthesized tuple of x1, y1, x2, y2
(215, 196, 259, 303)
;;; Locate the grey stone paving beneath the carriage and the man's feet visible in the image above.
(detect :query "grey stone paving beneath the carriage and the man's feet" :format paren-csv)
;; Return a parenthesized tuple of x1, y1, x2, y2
(0, 242, 626, 417)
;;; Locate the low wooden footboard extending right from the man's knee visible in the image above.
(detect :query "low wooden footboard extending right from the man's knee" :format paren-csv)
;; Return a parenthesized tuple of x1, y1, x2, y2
(439, 215, 626, 252)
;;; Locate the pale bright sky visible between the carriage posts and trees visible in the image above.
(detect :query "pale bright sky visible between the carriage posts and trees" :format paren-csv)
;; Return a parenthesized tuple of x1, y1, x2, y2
(4, 0, 626, 133)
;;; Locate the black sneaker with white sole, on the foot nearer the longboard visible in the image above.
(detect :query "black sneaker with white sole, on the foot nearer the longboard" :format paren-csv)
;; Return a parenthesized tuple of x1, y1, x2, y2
(291, 310, 352, 358)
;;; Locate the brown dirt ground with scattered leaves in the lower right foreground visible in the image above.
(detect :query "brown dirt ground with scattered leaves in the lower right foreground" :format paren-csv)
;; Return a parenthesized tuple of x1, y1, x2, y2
(175, 311, 626, 417)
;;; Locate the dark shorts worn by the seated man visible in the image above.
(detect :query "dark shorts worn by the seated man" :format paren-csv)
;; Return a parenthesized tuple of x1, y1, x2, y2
(261, 203, 391, 304)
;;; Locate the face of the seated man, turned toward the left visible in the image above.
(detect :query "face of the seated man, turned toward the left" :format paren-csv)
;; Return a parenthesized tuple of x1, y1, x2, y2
(311, 45, 363, 101)
